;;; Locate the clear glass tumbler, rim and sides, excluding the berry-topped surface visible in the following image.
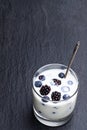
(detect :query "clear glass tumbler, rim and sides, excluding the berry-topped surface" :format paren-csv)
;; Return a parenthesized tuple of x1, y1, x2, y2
(32, 63, 79, 126)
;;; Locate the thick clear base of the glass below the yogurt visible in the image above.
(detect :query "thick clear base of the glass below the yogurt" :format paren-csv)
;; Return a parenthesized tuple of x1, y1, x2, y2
(33, 107, 73, 127)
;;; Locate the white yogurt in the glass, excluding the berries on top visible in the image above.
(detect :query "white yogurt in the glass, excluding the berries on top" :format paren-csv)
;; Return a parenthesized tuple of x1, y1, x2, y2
(32, 64, 78, 126)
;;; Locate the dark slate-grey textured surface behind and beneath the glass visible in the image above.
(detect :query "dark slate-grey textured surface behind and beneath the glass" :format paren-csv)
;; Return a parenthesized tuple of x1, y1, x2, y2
(0, 0, 87, 130)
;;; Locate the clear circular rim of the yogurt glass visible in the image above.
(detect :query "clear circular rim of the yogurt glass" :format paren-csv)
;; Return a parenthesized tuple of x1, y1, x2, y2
(32, 63, 79, 103)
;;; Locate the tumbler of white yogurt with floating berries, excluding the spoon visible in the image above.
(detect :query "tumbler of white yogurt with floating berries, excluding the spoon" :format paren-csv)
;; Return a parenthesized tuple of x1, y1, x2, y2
(32, 64, 78, 126)
